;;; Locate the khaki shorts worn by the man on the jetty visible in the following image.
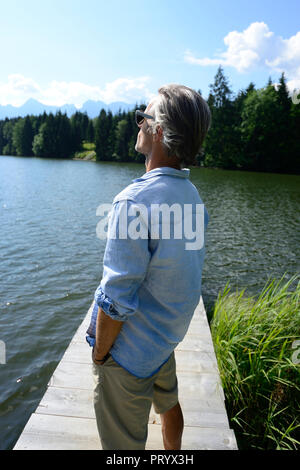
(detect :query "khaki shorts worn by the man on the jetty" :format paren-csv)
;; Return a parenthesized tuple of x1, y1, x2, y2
(93, 352, 178, 450)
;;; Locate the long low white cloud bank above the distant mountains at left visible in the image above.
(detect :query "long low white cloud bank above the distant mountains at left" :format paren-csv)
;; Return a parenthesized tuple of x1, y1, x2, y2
(0, 74, 154, 108)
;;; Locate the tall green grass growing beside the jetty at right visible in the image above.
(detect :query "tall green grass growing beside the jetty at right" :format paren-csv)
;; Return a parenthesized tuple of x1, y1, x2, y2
(211, 274, 300, 450)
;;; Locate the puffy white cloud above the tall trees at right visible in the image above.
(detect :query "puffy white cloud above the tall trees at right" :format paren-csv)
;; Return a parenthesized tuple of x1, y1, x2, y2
(184, 22, 300, 90)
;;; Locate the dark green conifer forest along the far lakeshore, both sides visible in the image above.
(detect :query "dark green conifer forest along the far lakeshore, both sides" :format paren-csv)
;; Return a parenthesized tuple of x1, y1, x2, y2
(0, 66, 300, 174)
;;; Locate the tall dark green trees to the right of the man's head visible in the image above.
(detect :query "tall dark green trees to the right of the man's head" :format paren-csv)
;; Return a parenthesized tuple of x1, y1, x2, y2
(204, 67, 300, 173)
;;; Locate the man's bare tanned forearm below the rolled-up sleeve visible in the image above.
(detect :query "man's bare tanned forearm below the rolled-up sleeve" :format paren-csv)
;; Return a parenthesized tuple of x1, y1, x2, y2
(93, 307, 123, 364)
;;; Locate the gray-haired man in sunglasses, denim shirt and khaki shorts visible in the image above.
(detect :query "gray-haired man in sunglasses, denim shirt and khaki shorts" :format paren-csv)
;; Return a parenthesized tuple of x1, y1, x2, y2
(87, 84, 211, 450)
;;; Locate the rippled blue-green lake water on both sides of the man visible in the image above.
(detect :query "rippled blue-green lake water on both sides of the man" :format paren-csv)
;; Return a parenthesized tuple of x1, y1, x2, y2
(0, 156, 300, 449)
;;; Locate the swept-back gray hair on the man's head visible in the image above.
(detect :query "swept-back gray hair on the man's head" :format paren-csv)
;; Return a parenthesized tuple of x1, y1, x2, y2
(148, 84, 211, 165)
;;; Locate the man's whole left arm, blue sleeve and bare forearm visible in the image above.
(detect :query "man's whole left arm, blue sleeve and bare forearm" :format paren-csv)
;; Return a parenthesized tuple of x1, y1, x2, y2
(93, 200, 151, 364)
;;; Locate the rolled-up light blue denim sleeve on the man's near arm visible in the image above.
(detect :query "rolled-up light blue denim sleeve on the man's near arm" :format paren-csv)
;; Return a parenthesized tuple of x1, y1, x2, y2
(95, 200, 151, 321)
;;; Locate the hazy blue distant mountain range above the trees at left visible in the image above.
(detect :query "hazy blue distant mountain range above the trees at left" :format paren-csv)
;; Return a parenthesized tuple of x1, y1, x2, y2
(0, 98, 135, 119)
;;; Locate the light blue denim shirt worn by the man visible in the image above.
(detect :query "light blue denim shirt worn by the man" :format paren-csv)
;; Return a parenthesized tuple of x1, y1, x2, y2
(86, 167, 209, 378)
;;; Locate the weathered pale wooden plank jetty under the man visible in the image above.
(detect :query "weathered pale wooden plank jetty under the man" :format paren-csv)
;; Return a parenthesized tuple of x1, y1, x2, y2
(14, 297, 237, 450)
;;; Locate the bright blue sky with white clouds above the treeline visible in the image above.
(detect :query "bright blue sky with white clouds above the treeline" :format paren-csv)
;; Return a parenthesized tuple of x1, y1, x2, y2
(0, 0, 300, 108)
